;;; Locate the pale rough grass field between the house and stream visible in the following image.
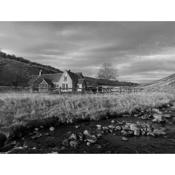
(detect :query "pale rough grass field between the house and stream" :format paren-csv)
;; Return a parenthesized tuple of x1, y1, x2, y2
(0, 92, 175, 129)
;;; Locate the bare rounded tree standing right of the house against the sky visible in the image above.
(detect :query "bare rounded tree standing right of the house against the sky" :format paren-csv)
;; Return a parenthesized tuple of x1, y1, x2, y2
(97, 63, 118, 80)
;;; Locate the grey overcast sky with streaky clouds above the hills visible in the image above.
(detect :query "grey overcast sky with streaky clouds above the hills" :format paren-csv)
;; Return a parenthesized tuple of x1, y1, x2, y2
(0, 22, 175, 82)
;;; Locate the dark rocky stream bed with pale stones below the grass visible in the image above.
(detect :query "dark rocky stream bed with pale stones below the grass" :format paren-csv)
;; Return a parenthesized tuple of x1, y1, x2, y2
(0, 100, 175, 153)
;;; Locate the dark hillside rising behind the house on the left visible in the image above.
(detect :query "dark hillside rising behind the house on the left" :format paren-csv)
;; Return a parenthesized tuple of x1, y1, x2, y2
(0, 51, 61, 86)
